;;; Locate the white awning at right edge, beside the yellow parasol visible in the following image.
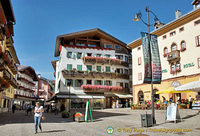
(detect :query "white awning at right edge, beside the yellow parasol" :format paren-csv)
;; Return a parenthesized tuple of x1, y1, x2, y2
(175, 79, 200, 92)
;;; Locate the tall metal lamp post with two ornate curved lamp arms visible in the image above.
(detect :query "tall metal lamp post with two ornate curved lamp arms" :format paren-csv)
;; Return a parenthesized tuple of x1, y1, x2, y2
(133, 6, 161, 124)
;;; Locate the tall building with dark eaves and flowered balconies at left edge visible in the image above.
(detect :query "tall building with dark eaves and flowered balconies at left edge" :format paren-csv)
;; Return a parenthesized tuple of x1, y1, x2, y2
(0, 0, 19, 112)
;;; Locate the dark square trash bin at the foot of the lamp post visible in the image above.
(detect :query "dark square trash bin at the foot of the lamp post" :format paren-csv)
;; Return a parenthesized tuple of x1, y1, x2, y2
(141, 114, 153, 127)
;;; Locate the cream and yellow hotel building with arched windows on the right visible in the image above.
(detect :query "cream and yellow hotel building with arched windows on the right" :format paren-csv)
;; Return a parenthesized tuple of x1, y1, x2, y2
(128, 2, 200, 104)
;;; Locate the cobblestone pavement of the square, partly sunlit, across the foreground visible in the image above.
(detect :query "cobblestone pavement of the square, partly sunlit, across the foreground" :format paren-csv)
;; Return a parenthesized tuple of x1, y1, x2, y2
(0, 109, 200, 136)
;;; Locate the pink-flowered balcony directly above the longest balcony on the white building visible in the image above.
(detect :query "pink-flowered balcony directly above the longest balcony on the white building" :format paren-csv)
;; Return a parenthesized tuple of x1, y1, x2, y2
(82, 56, 129, 67)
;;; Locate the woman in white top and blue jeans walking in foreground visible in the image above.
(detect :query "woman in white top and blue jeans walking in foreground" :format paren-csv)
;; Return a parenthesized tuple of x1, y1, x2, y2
(34, 102, 44, 134)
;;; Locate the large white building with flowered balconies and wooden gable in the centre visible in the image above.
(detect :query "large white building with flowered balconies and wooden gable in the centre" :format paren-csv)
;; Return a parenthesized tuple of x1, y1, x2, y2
(52, 28, 131, 108)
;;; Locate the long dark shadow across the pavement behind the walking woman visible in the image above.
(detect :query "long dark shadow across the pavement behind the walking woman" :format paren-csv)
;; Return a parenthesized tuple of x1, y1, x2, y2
(0, 111, 129, 126)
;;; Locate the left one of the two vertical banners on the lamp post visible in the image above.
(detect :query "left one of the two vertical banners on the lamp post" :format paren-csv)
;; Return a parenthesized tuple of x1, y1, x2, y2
(141, 32, 152, 84)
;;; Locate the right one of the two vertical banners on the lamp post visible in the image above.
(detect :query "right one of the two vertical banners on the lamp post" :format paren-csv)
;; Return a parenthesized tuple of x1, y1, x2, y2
(150, 34, 162, 84)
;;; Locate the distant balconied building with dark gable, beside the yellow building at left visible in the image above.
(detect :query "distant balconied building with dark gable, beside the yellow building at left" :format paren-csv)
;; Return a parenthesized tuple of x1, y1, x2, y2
(14, 65, 37, 109)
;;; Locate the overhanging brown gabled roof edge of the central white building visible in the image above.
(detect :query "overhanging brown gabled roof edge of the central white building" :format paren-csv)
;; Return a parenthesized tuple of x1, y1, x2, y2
(55, 28, 126, 57)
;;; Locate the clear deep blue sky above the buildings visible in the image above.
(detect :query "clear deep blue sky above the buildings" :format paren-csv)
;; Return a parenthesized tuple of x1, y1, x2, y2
(11, 0, 193, 79)
